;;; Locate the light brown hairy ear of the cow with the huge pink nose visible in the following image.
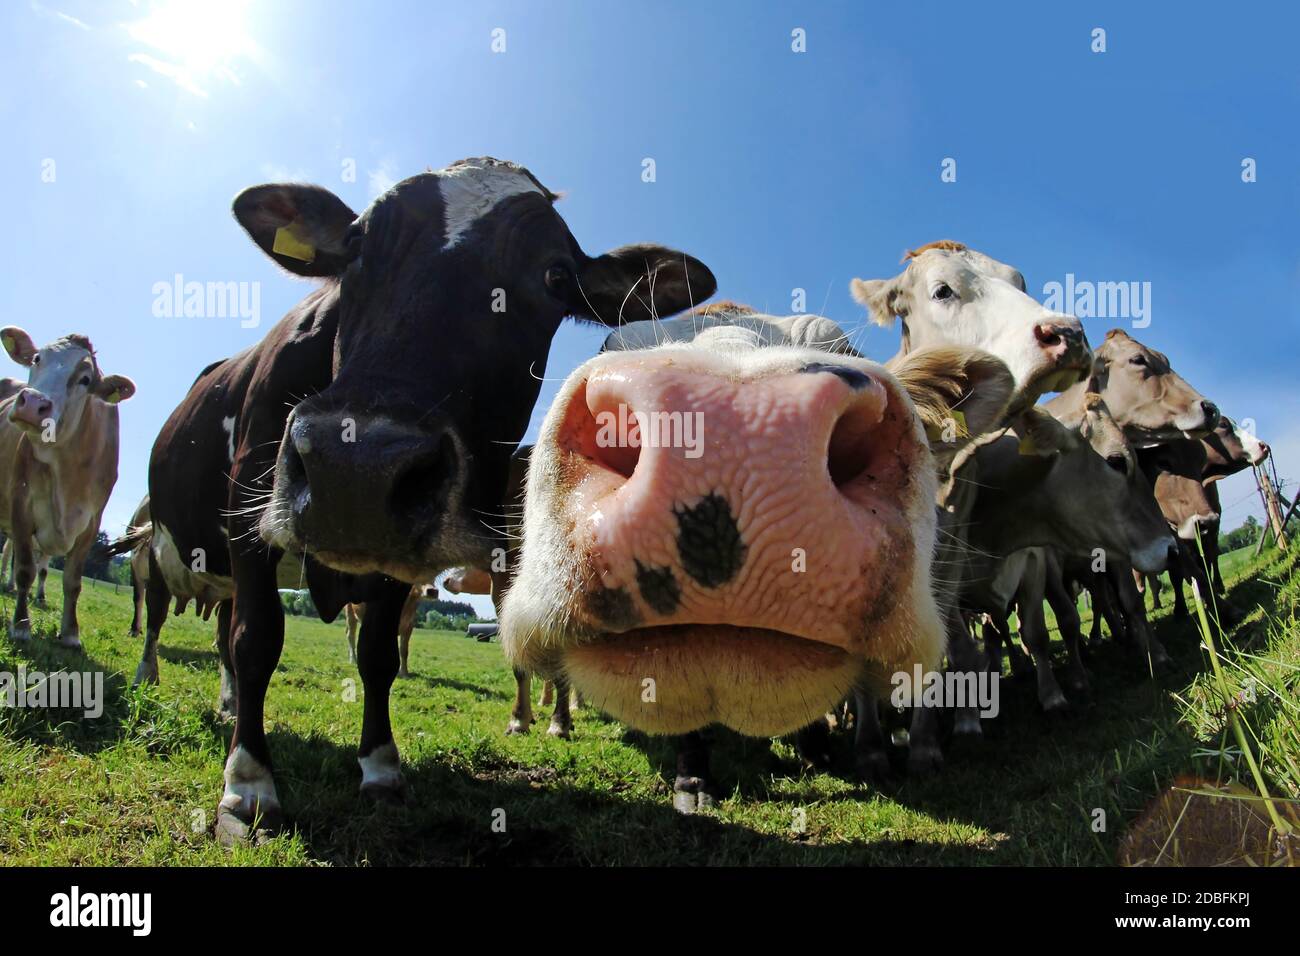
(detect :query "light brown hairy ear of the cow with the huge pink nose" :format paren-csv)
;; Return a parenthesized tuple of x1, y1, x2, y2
(887, 346, 1015, 470)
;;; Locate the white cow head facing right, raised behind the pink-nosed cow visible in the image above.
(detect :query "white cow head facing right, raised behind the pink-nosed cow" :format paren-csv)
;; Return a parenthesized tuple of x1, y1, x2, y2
(852, 239, 1092, 412)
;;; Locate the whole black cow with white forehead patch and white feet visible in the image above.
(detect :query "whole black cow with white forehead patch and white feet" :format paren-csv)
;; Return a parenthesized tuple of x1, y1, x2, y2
(146, 159, 716, 843)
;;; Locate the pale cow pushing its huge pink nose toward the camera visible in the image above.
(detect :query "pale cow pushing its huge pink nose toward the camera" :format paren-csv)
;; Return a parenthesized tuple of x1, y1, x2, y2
(499, 304, 1014, 812)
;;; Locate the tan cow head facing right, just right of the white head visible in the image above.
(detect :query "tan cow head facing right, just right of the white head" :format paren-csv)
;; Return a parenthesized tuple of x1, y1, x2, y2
(1088, 329, 1219, 445)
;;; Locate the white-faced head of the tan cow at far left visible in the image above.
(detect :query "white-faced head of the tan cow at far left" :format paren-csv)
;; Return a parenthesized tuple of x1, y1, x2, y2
(0, 325, 135, 457)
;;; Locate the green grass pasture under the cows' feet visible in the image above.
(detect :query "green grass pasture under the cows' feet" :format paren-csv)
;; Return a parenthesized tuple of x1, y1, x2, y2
(0, 553, 1300, 866)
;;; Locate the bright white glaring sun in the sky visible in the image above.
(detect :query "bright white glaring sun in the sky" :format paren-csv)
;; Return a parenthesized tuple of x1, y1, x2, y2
(126, 0, 254, 77)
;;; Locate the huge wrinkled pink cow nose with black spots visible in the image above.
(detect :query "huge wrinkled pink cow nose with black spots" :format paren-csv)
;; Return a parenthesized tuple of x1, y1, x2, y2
(556, 354, 924, 646)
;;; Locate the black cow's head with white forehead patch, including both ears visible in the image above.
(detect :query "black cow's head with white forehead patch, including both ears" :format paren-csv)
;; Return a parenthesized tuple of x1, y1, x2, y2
(234, 159, 715, 581)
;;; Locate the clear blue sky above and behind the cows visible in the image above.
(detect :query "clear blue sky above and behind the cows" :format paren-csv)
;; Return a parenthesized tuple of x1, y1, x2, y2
(0, 0, 1300, 621)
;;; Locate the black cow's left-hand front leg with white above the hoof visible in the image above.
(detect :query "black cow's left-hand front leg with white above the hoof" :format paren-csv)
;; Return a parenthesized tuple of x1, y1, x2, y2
(215, 551, 287, 845)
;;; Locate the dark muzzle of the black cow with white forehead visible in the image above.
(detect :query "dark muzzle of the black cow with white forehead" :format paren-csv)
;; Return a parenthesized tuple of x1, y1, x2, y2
(261, 406, 467, 581)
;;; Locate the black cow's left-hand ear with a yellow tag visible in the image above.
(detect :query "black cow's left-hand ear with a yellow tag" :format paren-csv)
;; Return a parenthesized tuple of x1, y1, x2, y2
(233, 183, 356, 277)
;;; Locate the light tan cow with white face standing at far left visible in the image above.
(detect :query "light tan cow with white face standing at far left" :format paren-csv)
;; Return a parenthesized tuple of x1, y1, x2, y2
(0, 325, 135, 648)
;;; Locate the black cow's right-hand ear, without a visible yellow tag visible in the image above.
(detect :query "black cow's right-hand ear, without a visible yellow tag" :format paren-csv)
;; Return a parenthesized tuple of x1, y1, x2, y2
(571, 243, 718, 328)
